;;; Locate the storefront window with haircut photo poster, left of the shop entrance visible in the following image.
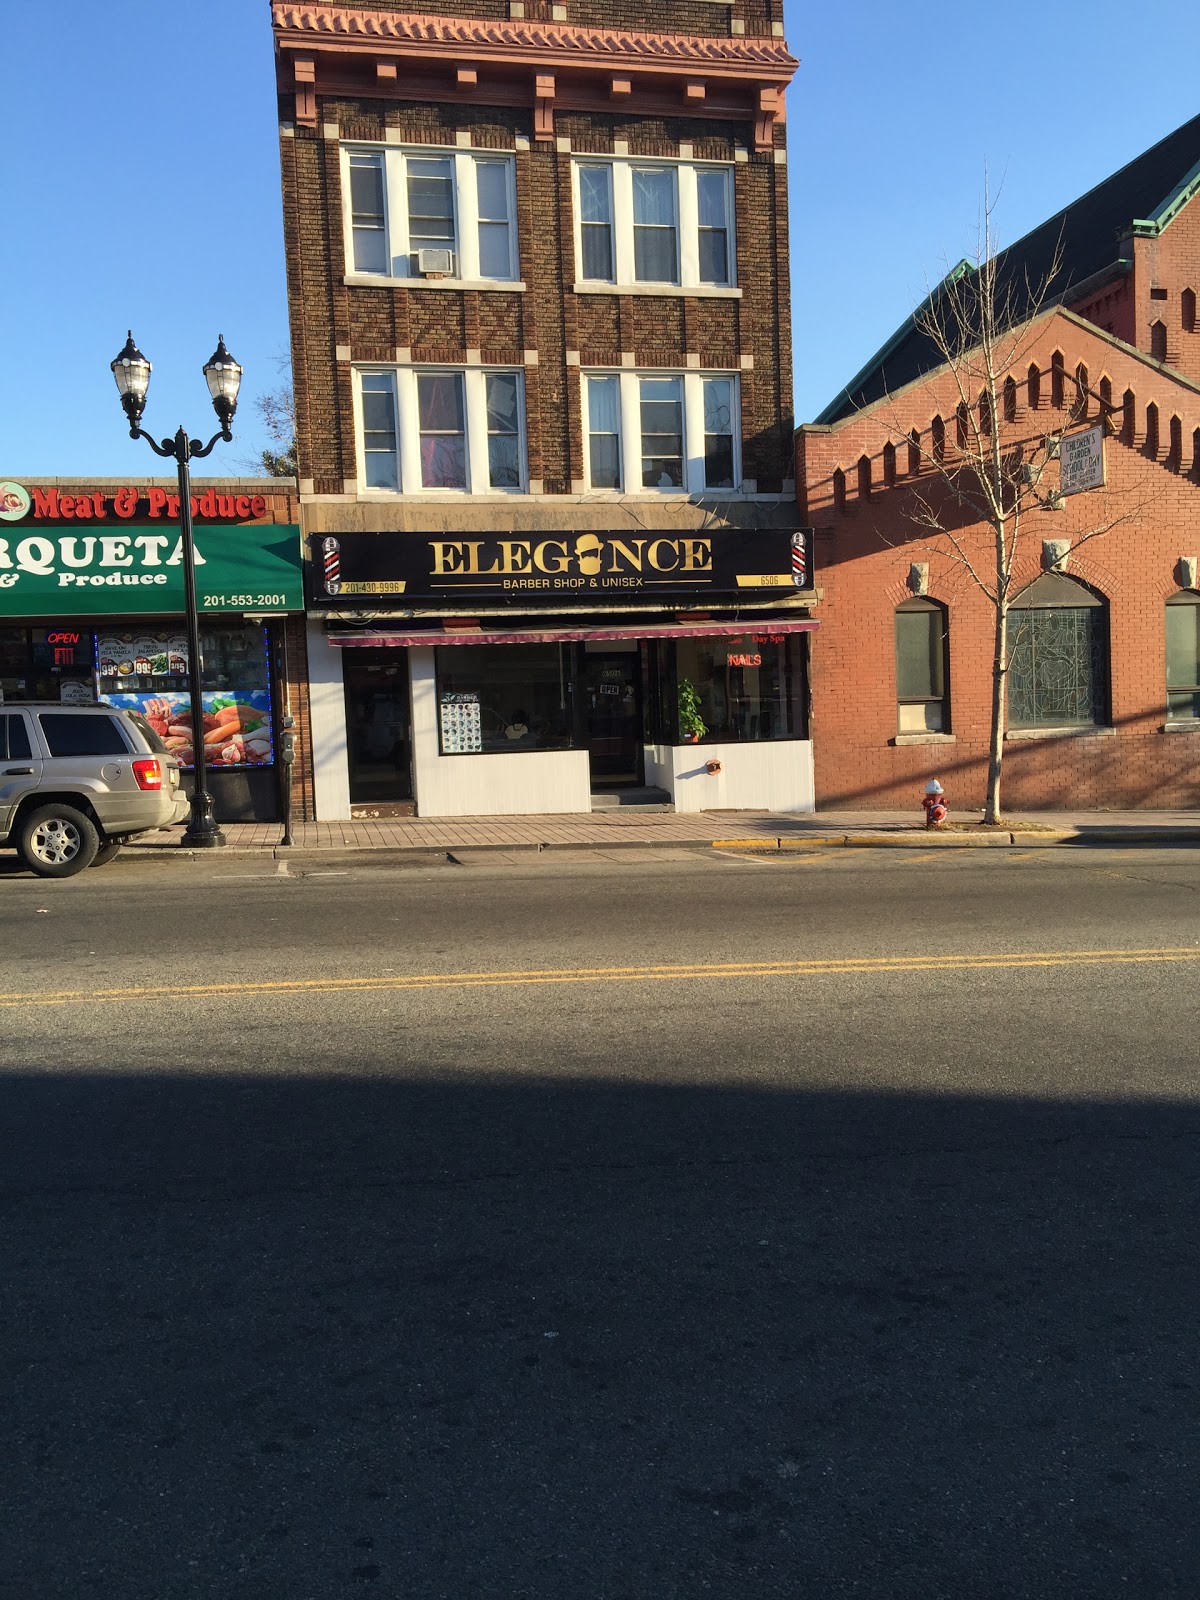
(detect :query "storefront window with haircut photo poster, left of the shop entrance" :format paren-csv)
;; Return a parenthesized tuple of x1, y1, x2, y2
(437, 645, 574, 755)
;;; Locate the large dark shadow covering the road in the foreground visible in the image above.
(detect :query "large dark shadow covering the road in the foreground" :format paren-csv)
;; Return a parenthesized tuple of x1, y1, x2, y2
(0, 1075, 1200, 1600)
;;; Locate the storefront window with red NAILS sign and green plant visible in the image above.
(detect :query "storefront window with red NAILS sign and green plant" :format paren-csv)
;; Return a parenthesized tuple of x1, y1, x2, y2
(659, 630, 805, 744)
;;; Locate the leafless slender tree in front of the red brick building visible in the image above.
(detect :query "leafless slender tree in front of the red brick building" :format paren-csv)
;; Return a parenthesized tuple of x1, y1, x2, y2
(896, 195, 1147, 824)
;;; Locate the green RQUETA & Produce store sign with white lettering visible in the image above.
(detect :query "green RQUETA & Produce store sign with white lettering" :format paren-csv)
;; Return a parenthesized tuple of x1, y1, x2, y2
(0, 523, 304, 614)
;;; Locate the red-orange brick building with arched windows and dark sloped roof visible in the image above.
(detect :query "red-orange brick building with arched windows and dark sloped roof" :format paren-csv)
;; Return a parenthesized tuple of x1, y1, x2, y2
(797, 118, 1200, 810)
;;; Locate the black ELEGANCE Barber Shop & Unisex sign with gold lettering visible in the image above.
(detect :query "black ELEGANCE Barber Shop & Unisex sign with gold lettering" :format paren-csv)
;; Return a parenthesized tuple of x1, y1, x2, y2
(310, 528, 813, 608)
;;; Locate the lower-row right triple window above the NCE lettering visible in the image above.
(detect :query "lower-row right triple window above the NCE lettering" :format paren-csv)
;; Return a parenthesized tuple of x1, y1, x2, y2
(584, 371, 741, 494)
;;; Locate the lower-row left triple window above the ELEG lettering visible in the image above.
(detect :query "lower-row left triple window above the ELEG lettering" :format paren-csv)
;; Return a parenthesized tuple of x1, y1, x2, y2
(358, 366, 526, 494)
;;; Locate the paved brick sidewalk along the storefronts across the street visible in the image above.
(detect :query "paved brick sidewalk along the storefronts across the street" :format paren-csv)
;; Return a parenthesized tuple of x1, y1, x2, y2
(128, 808, 1200, 856)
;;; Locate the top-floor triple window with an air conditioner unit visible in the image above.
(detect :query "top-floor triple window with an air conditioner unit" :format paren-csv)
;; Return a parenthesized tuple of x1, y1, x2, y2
(342, 146, 517, 283)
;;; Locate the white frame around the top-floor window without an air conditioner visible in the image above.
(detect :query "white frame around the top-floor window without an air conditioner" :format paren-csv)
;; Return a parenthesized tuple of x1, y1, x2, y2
(571, 155, 741, 298)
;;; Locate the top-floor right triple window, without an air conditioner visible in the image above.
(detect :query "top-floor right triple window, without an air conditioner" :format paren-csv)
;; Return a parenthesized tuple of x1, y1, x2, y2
(574, 157, 736, 288)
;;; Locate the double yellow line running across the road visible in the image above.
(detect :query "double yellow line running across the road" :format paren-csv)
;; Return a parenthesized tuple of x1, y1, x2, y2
(0, 946, 1200, 1008)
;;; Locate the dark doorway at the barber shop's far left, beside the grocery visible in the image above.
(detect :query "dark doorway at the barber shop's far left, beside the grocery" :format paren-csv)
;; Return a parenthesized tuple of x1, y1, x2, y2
(342, 650, 413, 805)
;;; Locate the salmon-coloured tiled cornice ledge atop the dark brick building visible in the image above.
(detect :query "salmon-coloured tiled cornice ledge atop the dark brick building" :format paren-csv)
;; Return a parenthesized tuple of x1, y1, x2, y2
(272, 0, 798, 78)
